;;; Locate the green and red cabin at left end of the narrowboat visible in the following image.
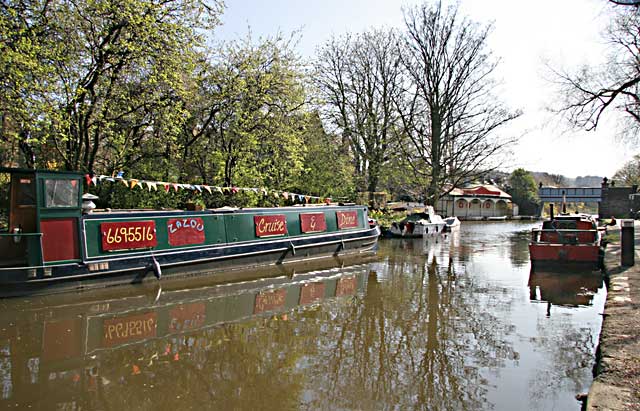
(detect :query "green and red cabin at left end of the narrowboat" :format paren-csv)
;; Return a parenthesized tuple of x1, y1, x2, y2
(0, 168, 82, 267)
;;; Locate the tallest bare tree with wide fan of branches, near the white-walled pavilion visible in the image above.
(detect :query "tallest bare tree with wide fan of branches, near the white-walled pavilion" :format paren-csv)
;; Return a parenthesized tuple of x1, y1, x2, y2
(397, 2, 520, 204)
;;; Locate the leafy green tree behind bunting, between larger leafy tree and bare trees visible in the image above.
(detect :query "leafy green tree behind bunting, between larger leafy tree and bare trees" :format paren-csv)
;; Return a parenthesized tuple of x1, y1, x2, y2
(179, 36, 306, 189)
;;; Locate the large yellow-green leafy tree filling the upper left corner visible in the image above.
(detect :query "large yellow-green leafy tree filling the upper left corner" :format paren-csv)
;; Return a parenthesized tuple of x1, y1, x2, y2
(0, 0, 222, 171)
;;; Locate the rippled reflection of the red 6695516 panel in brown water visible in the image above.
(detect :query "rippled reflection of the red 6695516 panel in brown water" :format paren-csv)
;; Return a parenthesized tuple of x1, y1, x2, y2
(102, 311, 158, 347)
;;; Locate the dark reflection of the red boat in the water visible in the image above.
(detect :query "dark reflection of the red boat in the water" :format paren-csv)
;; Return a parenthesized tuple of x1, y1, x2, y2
(529, 269, 604, 315)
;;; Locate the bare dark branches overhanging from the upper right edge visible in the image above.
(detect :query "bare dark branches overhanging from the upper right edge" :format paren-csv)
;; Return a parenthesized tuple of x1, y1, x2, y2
(553, 1, 640, 139)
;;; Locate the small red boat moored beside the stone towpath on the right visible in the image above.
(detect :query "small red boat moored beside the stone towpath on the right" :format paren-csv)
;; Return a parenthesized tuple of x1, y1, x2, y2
(529, 211, 602, 268)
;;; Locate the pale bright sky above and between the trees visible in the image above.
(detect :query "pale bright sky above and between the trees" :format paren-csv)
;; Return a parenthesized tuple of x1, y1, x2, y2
(214, 0, 640, 177)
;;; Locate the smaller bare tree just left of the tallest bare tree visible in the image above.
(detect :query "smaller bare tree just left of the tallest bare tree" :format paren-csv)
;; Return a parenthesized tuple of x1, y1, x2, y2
(315, 30, 401, 191)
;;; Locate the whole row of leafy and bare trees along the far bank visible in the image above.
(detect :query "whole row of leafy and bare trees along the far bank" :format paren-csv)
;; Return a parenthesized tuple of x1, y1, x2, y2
(0, 0, 520, 207)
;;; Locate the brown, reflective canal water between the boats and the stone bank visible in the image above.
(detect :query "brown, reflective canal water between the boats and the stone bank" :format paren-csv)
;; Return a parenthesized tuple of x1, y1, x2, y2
(0, 222, 605, 410)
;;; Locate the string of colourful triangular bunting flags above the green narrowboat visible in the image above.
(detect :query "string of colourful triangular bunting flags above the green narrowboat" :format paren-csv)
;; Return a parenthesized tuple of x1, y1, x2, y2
(85, 172, 331, 204)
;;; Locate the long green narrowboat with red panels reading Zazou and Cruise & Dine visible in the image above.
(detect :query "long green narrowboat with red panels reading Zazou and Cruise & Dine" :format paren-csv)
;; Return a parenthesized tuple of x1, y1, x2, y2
(0, 168, 379, 296)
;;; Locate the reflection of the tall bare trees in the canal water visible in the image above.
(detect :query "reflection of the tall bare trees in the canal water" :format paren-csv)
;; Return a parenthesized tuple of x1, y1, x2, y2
(308, 240, 517, 410)
